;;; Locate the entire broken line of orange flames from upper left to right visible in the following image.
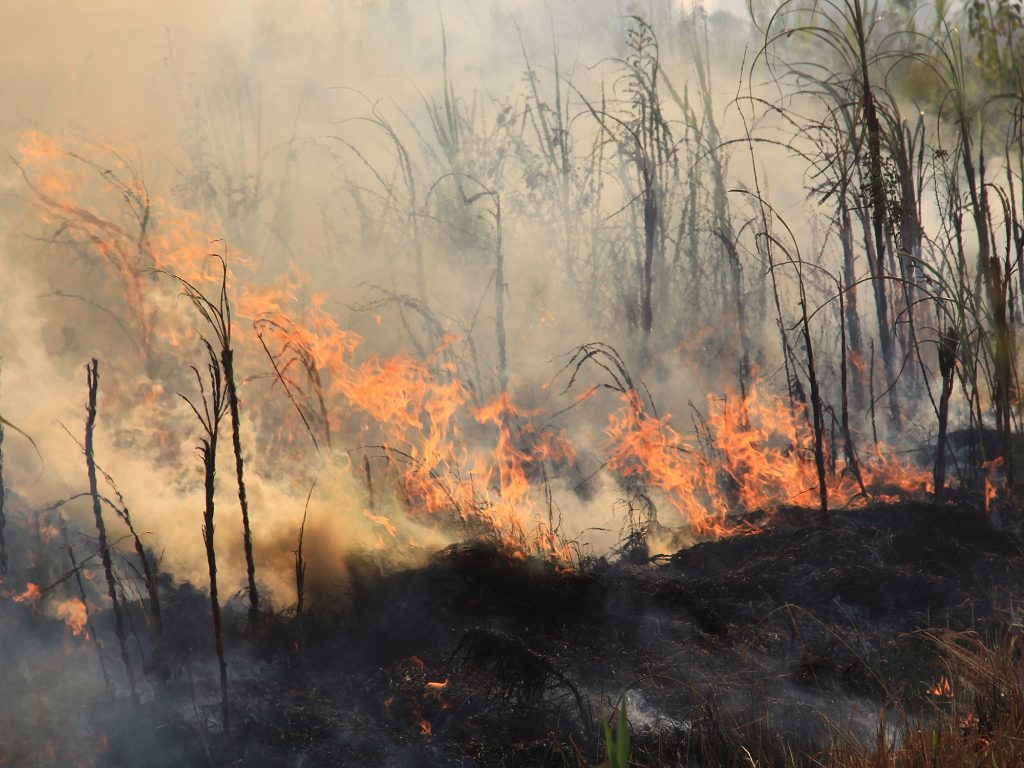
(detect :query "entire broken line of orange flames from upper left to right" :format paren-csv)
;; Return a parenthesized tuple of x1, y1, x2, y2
(19, 132, 942, 581)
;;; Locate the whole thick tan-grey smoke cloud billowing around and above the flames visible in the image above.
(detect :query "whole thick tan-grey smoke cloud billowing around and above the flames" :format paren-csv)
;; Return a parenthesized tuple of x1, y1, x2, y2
(0, 0, 950, 622)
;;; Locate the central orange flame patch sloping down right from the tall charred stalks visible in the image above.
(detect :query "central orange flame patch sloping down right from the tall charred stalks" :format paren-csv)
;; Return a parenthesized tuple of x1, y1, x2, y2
(245, 270, 574, 560)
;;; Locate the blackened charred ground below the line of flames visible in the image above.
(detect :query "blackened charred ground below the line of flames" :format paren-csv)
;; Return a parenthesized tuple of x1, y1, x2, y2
(0, 503, 1024, 767)
